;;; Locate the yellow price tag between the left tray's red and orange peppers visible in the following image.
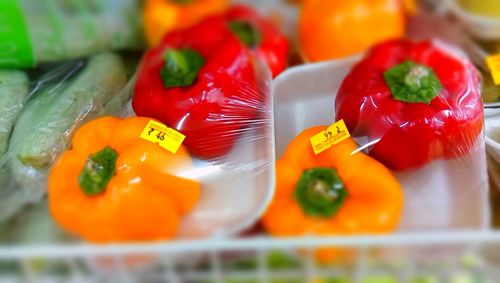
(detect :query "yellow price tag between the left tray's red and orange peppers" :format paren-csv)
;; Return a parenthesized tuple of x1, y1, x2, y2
(139, 120, 186, 154)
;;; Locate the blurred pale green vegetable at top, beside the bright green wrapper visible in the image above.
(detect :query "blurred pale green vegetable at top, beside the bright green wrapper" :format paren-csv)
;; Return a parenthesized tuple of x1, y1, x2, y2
(14, 0, 144, 65)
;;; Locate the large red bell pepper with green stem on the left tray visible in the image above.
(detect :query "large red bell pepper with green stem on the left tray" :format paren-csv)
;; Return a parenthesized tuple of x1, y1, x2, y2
(132, 17, 264, 159)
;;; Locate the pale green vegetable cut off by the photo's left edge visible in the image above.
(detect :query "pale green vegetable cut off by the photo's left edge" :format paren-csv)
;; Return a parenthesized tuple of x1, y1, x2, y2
(0, 70, 29, 157)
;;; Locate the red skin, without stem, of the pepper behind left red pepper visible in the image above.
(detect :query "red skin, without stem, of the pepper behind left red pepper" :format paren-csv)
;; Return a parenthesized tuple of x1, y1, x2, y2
(225, 5, 290, 78)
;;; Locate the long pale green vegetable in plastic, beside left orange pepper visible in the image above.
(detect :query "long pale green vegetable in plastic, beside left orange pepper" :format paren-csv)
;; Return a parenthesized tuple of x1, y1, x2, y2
(10, 53, 127, 170)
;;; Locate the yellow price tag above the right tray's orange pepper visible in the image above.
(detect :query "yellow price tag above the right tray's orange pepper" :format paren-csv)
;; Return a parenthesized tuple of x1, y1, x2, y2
(310, 120, 351, 154)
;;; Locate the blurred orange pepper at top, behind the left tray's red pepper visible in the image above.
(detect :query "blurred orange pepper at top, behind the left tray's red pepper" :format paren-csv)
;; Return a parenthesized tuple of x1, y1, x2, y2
(143, 0, 229, 46)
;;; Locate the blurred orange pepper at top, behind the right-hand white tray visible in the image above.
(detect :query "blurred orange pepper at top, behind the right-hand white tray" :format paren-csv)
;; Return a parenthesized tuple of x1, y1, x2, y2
(299, 0, 408, 62)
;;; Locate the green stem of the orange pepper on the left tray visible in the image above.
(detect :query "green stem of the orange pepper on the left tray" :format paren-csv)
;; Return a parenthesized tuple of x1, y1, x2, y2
(78, 146, 118, 196)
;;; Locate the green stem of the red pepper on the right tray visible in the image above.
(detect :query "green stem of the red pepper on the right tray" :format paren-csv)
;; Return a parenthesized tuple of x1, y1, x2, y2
(384, 60, 443, 104)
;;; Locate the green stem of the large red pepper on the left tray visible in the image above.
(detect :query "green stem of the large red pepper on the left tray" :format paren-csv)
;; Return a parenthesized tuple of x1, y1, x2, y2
(161, 48, 205, 88)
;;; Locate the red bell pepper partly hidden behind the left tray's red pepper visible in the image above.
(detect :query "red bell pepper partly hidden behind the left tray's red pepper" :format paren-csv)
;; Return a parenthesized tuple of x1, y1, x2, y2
(225, 5, 290, 77)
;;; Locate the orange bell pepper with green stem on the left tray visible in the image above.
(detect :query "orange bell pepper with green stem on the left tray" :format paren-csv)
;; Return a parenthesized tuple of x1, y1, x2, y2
(48, 117, 200, 243)
